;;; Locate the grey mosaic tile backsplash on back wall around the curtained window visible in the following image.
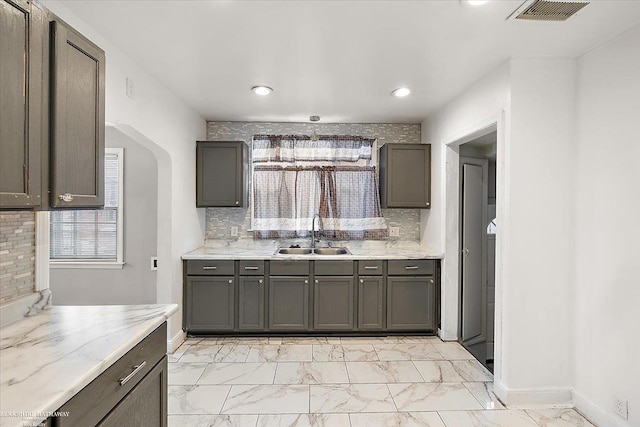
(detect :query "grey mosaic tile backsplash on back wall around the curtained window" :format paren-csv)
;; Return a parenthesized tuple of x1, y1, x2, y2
(206, 122, 420, 241)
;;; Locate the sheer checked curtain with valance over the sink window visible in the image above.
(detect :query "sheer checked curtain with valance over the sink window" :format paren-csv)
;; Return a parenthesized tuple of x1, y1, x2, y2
(253, 136, 388, 239)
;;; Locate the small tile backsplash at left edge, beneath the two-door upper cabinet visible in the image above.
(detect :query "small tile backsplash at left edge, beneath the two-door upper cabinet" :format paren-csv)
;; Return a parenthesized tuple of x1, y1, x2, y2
(0, 211, 36, 305)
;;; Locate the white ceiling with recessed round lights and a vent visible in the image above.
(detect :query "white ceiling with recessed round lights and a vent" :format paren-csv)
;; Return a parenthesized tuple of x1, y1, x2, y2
(58, 0, 640, 123)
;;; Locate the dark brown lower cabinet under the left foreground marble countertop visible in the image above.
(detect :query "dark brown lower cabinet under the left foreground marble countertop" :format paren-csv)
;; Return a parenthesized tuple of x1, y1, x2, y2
(51, 323, 168, 427)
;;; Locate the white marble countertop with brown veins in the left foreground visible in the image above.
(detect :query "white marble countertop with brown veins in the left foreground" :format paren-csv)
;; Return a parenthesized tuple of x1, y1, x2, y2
(0, 304, 178, 427)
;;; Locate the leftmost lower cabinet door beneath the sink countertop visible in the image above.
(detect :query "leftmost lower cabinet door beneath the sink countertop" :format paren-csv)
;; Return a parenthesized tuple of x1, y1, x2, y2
(185, 276, 235, 332)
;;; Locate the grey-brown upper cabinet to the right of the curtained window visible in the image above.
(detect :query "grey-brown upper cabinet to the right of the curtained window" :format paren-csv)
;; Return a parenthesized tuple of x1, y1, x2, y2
(380, 144, 431, 209)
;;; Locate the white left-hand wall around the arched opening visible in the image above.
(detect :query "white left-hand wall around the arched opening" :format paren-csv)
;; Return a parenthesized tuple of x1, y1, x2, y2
(45, 1, 206, 348)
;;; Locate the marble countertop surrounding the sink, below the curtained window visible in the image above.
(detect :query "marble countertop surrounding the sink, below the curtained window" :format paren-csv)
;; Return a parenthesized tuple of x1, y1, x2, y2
(182, 239, 443, 260)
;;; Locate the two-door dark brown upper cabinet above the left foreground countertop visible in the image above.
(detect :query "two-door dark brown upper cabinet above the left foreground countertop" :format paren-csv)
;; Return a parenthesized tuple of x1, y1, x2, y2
(0, 0, 105, 209)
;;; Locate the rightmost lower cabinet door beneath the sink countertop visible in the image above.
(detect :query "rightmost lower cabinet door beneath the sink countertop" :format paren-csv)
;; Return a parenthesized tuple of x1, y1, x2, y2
(387, 276, 436, 330)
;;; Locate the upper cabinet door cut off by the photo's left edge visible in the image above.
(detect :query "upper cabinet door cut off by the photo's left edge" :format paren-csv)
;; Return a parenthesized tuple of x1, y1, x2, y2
(0, 0, 46, 208)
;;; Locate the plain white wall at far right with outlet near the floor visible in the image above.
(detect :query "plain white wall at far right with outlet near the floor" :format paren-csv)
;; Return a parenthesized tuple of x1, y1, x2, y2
(572, 25, 640, 426)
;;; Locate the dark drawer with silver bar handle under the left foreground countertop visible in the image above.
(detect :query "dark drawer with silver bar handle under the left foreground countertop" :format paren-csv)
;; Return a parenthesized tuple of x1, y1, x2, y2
(53, 323, 167, 426)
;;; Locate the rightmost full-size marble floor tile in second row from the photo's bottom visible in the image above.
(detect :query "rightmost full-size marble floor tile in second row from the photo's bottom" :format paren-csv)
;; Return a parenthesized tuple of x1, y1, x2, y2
(388, 383, 482, 412)
